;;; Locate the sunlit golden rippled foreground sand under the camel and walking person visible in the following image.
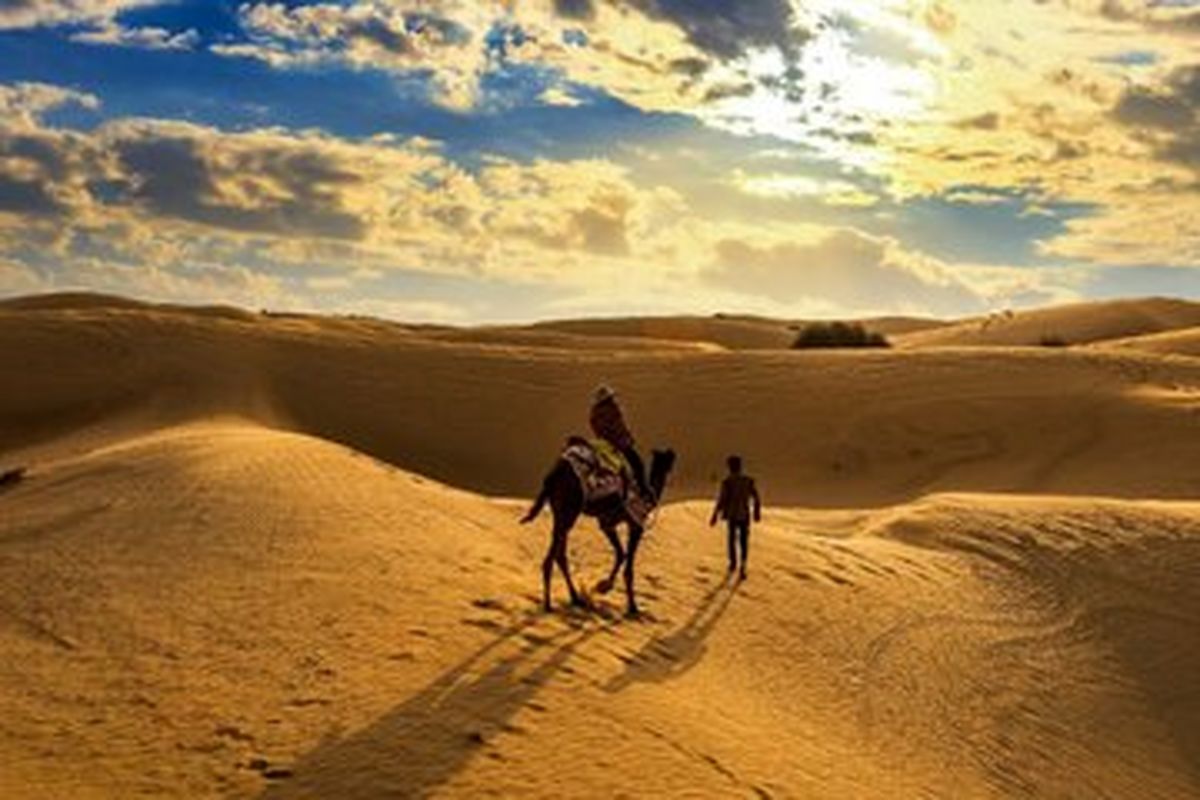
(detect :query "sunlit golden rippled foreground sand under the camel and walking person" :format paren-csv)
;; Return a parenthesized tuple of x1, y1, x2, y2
(0, 423, 1200, 798)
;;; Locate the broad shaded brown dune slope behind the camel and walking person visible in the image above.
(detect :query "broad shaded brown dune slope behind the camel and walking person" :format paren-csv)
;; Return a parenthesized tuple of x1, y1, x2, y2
(0, 299, 1200, 506)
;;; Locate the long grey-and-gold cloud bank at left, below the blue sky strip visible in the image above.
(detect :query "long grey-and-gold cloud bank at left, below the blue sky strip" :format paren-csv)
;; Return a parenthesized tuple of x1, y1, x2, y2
(0, 86, 686, 307)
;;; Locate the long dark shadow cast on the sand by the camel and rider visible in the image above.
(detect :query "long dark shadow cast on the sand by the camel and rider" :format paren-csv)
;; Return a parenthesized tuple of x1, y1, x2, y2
(259, 615, 600, 800)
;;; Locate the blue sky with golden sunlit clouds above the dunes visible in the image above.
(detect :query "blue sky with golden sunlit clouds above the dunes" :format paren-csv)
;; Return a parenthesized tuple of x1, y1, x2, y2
(0, 0, 1200, 323)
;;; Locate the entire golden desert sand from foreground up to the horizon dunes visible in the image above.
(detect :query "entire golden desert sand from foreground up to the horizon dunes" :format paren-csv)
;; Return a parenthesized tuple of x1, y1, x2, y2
(0, 295, 1200, 798)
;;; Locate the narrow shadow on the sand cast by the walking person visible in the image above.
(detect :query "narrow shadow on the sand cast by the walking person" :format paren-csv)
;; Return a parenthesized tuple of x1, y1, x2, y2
(604, 583, 737, 692)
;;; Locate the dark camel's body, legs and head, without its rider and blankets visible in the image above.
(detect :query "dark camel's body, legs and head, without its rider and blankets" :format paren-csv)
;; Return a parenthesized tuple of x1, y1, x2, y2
(521, 450, 676, 616)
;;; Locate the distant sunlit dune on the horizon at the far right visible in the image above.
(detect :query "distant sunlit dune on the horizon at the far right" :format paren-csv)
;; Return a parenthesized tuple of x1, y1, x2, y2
(894, 297, 1200, 348)
